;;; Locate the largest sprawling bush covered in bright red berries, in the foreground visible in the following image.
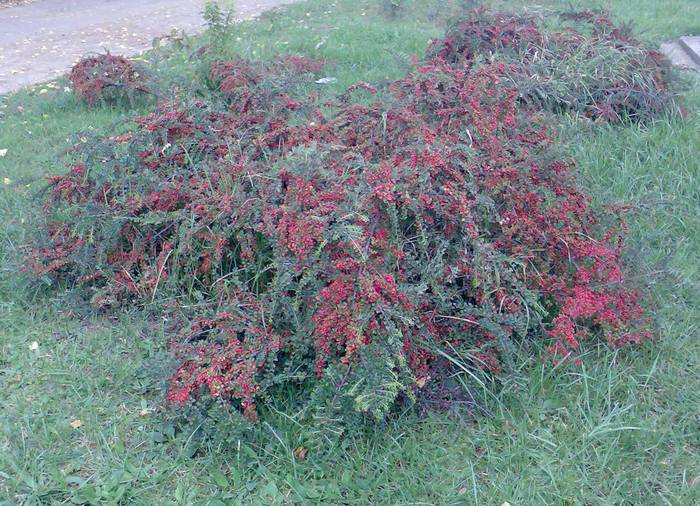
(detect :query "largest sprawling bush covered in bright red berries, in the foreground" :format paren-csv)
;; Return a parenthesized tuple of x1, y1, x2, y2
(23, 9, 648, 426)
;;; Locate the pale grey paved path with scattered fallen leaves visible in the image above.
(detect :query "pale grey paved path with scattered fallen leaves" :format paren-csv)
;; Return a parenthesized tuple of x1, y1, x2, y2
(0, 0, 292, 93)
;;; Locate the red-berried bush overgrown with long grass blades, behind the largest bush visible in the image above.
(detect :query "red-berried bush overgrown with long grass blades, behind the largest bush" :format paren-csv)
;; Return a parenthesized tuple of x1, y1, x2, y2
(428, 9, 677, 121)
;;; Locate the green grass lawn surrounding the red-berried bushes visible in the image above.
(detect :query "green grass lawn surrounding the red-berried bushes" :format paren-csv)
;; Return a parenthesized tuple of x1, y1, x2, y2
(0, 0, 700, 506)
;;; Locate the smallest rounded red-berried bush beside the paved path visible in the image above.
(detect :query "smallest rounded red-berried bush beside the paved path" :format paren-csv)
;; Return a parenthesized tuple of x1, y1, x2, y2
(70, 53, 149, 105)
